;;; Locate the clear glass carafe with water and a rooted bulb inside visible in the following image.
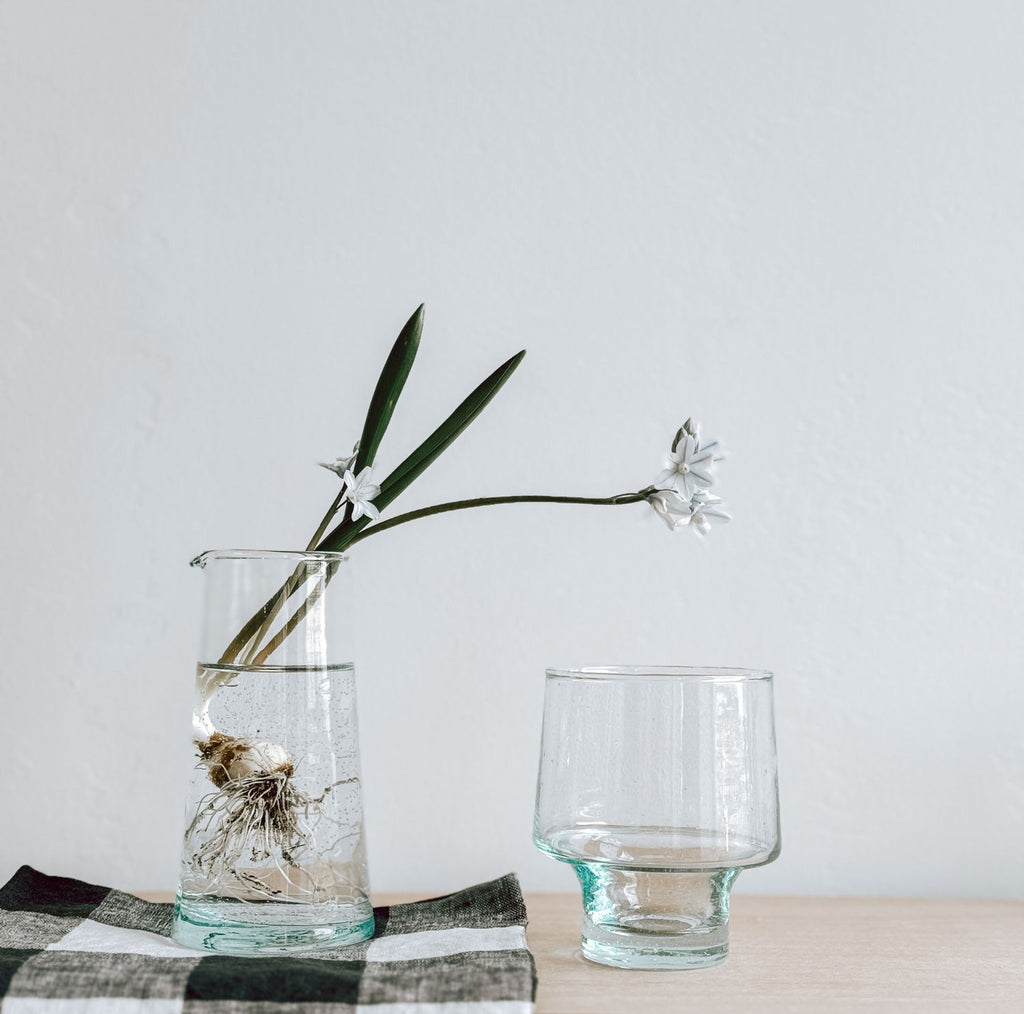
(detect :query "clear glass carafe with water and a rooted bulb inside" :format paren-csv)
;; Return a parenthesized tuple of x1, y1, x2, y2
(173, 550, 374, 955)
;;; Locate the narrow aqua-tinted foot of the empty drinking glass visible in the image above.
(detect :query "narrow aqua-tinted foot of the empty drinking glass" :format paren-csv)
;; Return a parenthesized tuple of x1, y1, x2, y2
(572, 862, 739, 969)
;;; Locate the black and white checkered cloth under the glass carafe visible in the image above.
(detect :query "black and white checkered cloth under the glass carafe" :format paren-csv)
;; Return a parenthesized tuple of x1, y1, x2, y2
(0, 867, 537, 1014)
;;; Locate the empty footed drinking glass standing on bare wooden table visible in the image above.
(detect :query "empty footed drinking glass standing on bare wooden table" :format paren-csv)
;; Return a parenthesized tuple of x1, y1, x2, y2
(534, 666, 779, 969)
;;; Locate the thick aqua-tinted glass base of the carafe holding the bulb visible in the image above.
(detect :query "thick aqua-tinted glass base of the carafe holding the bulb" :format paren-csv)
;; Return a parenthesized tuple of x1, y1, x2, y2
(171, 893, 374, 956)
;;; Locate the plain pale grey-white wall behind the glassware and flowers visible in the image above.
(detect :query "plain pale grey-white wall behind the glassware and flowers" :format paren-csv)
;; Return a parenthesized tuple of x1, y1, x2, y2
(0, 0, 1024, 896)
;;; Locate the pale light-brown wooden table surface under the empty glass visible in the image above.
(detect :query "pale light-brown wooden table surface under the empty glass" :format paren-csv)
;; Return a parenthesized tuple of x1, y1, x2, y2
(144, 893, 1024, 1014)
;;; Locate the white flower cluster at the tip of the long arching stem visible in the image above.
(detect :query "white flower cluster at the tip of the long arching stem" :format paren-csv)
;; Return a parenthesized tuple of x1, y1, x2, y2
(646, 419, 729, 535)
